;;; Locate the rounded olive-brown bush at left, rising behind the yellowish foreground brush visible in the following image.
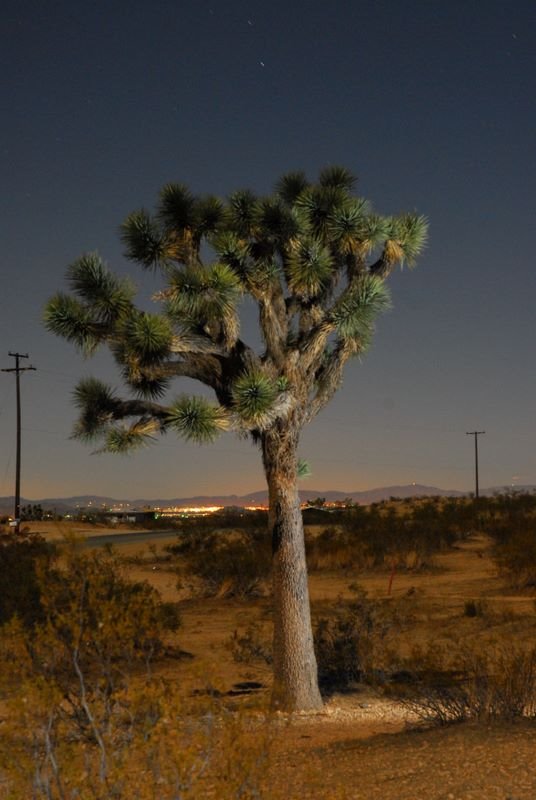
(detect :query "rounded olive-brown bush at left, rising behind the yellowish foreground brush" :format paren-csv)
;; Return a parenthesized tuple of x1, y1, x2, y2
(0, 545, 180, 720)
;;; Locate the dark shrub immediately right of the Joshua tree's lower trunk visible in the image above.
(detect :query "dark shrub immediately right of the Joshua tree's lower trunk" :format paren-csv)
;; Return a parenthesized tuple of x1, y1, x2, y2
(314, 587, 392, 692)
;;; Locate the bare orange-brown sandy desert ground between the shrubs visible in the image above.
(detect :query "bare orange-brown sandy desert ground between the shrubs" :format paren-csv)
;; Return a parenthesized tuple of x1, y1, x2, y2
(13, 523, 536, 800)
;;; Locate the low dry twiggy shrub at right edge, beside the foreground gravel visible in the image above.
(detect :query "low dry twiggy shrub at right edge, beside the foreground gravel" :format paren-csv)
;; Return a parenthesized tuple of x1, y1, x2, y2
(396, 642, 536, 724)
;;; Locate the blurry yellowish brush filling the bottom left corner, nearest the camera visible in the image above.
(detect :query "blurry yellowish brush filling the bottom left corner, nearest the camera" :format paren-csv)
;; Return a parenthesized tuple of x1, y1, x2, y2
(0, 660, 273, 800)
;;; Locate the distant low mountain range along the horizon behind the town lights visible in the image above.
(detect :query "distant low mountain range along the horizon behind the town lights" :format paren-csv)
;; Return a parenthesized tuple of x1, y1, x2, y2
(0, 483, 536, 514)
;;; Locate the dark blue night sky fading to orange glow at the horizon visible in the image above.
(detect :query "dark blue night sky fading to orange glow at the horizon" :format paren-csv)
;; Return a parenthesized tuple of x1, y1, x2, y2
(0, 0, 536, 499)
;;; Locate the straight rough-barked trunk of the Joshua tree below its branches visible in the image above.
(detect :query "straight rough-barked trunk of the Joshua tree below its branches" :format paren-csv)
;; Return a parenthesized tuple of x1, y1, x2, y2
(262, 422, 322, 711)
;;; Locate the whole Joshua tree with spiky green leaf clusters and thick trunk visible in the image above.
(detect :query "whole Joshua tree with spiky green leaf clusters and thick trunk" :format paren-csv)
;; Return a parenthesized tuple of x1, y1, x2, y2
(45, 167, 427, 709)
